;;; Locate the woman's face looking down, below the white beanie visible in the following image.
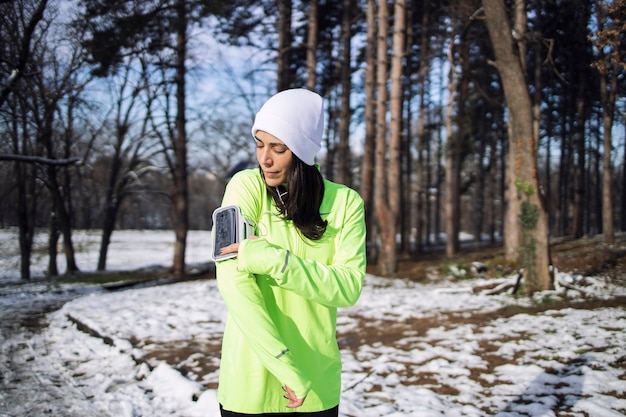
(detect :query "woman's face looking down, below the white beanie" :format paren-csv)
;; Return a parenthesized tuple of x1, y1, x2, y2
(255, 130, 293, 187)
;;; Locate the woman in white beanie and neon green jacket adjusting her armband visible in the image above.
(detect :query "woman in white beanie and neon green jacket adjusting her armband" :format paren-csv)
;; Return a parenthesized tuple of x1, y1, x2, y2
(216, 89, 366, 417)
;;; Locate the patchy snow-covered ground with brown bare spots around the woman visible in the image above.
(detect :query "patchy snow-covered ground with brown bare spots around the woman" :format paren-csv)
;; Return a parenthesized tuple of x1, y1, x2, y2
(0, 231, 626, 417)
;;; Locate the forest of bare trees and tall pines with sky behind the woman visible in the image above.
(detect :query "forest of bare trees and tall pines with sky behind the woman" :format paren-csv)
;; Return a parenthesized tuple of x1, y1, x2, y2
(0, 0, 626, 293)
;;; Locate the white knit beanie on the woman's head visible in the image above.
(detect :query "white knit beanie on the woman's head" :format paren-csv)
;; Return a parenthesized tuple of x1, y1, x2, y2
(252, 88, 324, 165)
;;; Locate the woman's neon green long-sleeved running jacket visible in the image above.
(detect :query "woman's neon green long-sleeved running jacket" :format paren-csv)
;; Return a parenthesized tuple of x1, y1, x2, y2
(216, 169, 366, 414)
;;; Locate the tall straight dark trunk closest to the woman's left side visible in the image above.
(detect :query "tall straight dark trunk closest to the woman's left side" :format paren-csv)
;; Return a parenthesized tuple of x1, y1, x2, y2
(172, 0, 189, 277)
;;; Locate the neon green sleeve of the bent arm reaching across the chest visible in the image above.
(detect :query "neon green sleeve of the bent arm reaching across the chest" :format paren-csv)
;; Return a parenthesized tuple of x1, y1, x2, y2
(239, 193, 366, 307)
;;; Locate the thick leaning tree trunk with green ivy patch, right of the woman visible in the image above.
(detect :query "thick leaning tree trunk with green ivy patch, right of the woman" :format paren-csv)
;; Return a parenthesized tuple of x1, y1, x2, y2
(482, 0, 553, 294)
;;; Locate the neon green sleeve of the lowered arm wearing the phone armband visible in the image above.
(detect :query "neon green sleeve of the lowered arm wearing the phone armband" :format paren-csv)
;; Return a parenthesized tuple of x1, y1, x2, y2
(216, 171, 311, 398)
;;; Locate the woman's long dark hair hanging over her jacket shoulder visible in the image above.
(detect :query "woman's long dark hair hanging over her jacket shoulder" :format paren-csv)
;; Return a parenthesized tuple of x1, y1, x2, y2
(261, 154, 328, 240)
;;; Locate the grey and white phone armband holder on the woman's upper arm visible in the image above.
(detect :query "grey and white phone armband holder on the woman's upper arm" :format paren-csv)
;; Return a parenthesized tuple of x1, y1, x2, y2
(212, 206, 254, 262)
